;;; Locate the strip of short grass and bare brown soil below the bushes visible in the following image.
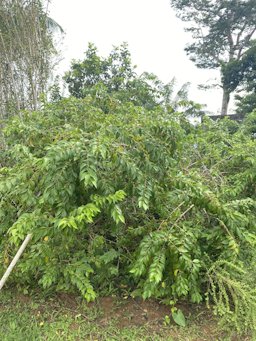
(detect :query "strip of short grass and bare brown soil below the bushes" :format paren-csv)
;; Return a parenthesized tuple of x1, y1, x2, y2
(0, 291, 253, 341)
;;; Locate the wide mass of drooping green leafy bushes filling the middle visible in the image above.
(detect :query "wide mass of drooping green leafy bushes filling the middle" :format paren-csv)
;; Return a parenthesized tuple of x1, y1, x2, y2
(0, 97, 256, 329)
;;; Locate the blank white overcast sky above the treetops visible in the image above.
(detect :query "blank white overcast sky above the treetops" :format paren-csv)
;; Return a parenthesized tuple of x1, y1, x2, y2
(49, 0, 225, 114)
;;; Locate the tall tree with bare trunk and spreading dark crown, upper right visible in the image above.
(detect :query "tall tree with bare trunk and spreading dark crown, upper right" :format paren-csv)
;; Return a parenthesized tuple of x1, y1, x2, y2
(170, 0, 256, 115)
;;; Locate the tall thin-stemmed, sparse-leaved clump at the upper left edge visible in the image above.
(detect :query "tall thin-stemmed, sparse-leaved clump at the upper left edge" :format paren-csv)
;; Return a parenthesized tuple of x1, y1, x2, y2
(0, 0, 61, 117)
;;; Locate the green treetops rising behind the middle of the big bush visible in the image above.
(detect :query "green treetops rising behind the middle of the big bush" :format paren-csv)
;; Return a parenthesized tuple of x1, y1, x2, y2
(64, 43, 198, 112)
